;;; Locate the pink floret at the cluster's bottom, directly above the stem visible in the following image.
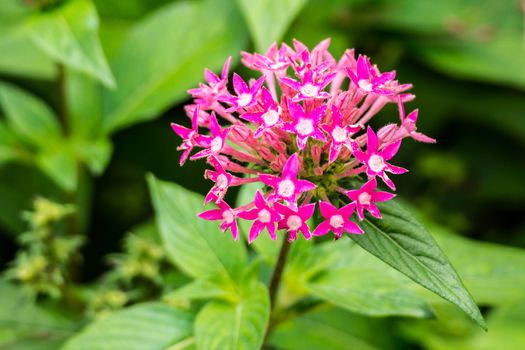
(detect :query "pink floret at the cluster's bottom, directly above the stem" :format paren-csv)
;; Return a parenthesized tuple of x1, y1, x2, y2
(275, 203, 315, 242)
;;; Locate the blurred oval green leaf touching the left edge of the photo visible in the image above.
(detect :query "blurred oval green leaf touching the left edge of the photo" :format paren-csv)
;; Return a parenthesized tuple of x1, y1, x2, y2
(0, 83, 62, 147)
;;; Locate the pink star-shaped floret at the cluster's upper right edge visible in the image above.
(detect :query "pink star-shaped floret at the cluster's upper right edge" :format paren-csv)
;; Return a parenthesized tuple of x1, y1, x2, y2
(346, 55, 396, 95)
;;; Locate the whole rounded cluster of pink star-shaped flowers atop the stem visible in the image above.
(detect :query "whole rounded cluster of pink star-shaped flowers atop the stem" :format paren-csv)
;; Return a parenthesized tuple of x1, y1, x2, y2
(171, 39, 435, 242)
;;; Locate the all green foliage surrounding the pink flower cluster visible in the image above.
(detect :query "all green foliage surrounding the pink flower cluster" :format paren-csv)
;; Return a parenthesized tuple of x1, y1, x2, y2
(0, 0, 525, 350)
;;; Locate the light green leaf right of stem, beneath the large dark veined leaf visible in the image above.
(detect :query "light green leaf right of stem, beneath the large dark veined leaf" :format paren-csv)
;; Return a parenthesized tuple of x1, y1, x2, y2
(308, 267, 433, 317)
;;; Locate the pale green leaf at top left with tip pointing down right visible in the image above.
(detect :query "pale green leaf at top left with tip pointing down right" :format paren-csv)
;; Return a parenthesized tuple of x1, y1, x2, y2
(29, 0, 115, 88)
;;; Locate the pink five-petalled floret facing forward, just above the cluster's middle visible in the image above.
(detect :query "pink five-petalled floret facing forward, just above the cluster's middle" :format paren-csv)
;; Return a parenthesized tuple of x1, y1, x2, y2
(283, 100, 326, 150)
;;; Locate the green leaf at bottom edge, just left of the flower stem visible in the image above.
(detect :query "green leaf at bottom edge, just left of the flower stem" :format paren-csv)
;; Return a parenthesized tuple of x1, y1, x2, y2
(195, 283, 270, 350)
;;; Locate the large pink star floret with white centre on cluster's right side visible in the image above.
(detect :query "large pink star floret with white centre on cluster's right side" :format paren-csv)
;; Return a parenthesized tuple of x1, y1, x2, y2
(351, 127, 408, 190)
